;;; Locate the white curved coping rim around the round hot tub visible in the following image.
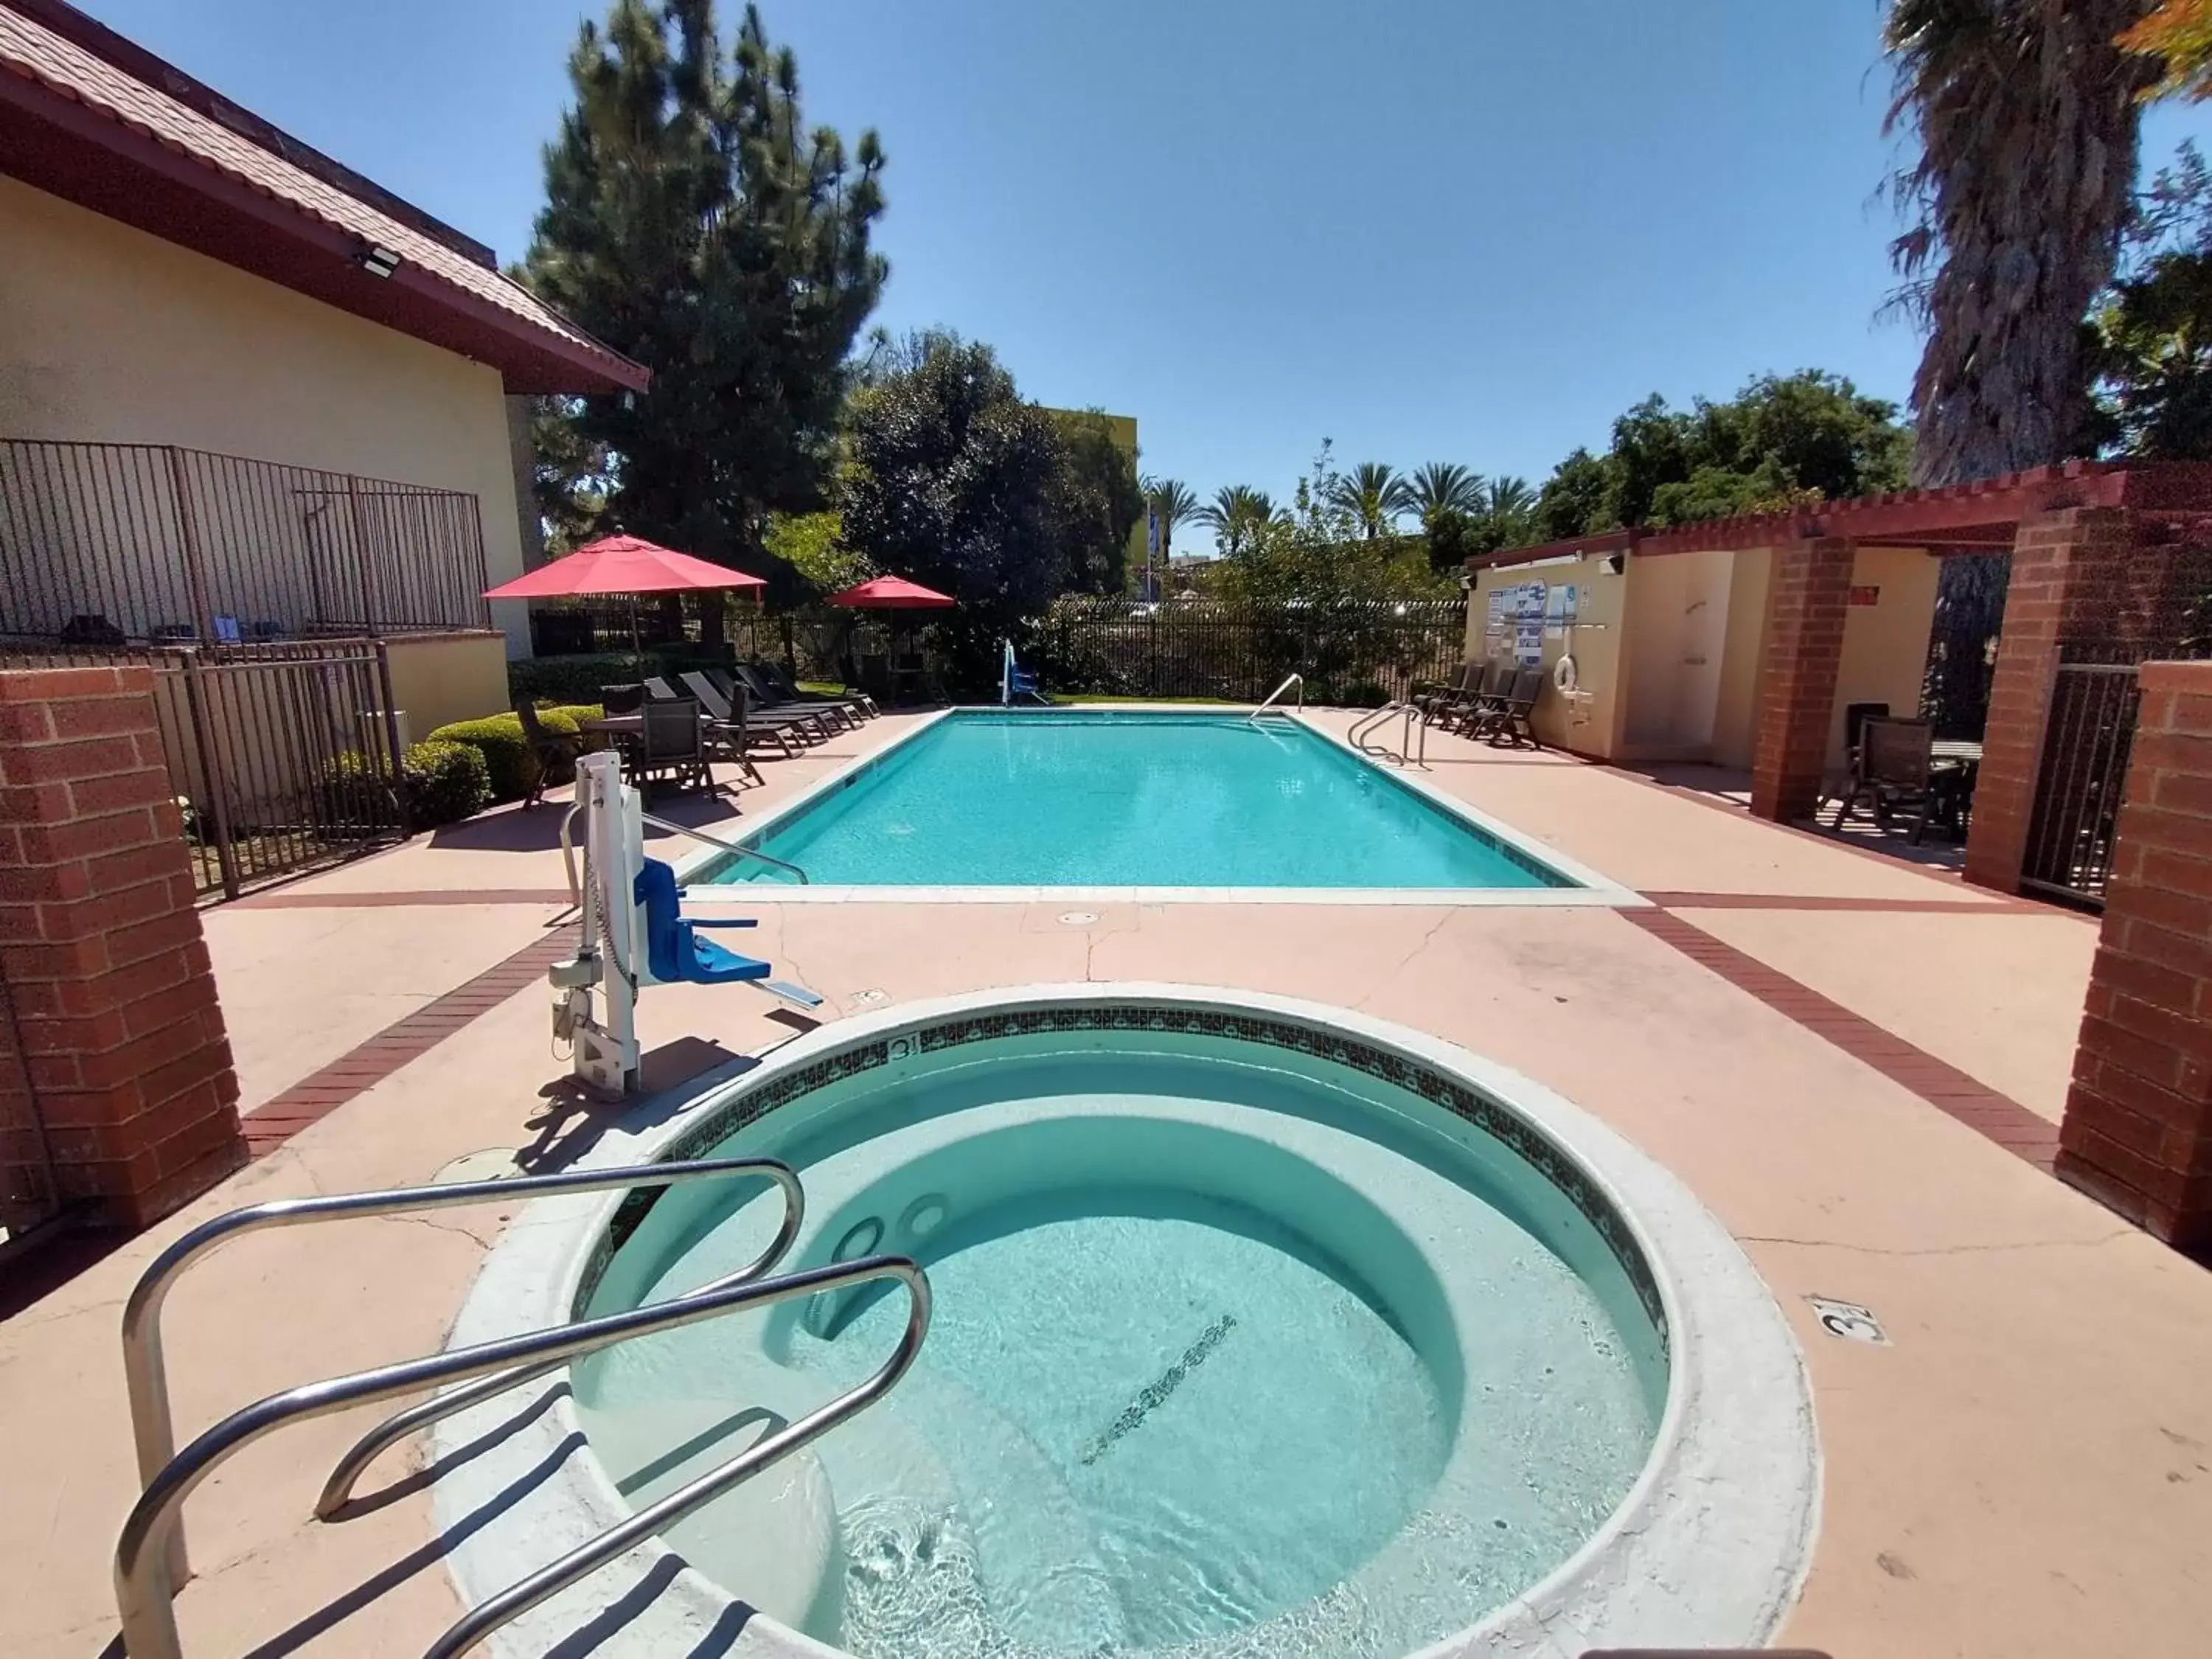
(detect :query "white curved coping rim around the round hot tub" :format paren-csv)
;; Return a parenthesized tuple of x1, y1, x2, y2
(431, 982, 1823, 1659)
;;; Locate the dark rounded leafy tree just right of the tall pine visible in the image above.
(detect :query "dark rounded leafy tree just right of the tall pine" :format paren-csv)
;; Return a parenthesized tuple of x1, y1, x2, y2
(841, 334, 1062, 684)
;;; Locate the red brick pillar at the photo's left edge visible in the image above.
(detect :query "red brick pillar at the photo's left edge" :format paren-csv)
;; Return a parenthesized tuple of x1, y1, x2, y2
(0, 668, 246, 1228)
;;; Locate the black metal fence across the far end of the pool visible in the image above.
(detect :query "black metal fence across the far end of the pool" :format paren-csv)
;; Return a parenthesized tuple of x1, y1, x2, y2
(1033, 599, 1467, 706)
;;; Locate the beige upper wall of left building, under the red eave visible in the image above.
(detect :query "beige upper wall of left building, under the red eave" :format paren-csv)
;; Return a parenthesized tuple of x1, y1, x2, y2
(0, 177, 529, 655)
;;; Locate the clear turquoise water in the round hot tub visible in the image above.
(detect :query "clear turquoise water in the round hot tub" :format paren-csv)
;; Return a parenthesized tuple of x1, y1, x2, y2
(575, 1033, 1666, 1659)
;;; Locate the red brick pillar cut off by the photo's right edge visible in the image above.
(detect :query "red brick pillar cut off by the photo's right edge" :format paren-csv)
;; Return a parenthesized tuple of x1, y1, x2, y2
(2057, 661, 2212, 1250)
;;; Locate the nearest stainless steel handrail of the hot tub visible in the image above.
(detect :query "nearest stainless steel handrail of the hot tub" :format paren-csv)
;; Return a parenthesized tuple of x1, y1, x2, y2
(115, 1256, 929, 1659)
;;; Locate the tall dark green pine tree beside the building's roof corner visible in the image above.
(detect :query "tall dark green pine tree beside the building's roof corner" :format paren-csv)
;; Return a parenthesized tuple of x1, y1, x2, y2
(524, 0, 887, 606)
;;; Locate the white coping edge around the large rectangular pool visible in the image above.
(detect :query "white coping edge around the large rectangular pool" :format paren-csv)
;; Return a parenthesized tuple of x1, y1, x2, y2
(675, 703, 1650, 909)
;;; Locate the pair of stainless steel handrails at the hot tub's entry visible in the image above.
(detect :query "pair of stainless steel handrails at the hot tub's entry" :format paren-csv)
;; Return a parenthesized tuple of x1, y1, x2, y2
(115, 1157, 929, 1659)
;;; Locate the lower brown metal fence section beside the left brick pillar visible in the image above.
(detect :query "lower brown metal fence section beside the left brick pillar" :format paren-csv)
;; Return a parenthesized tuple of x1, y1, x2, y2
(150, 639, 407, 898)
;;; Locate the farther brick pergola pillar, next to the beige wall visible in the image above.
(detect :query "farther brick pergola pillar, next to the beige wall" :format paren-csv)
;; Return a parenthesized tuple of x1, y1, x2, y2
(1752, 535, 1851, 823)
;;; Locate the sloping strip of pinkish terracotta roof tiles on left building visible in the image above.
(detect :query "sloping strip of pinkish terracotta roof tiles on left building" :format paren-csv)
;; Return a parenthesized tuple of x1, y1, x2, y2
(0, 7, 641, 383)
